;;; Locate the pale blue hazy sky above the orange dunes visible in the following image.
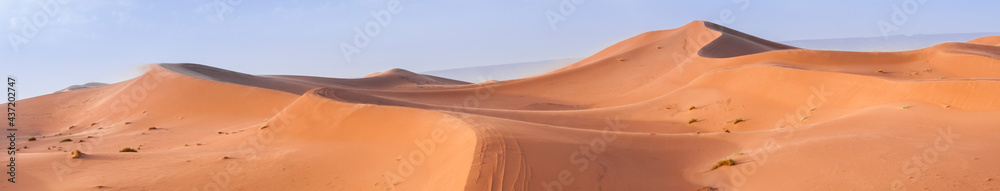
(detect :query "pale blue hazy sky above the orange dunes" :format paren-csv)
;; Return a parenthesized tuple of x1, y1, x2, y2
(0, 0, 1000, 99)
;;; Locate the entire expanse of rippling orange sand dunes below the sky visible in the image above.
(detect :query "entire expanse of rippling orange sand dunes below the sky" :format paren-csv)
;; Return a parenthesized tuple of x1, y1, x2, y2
(4, 21, 1000, 190)
